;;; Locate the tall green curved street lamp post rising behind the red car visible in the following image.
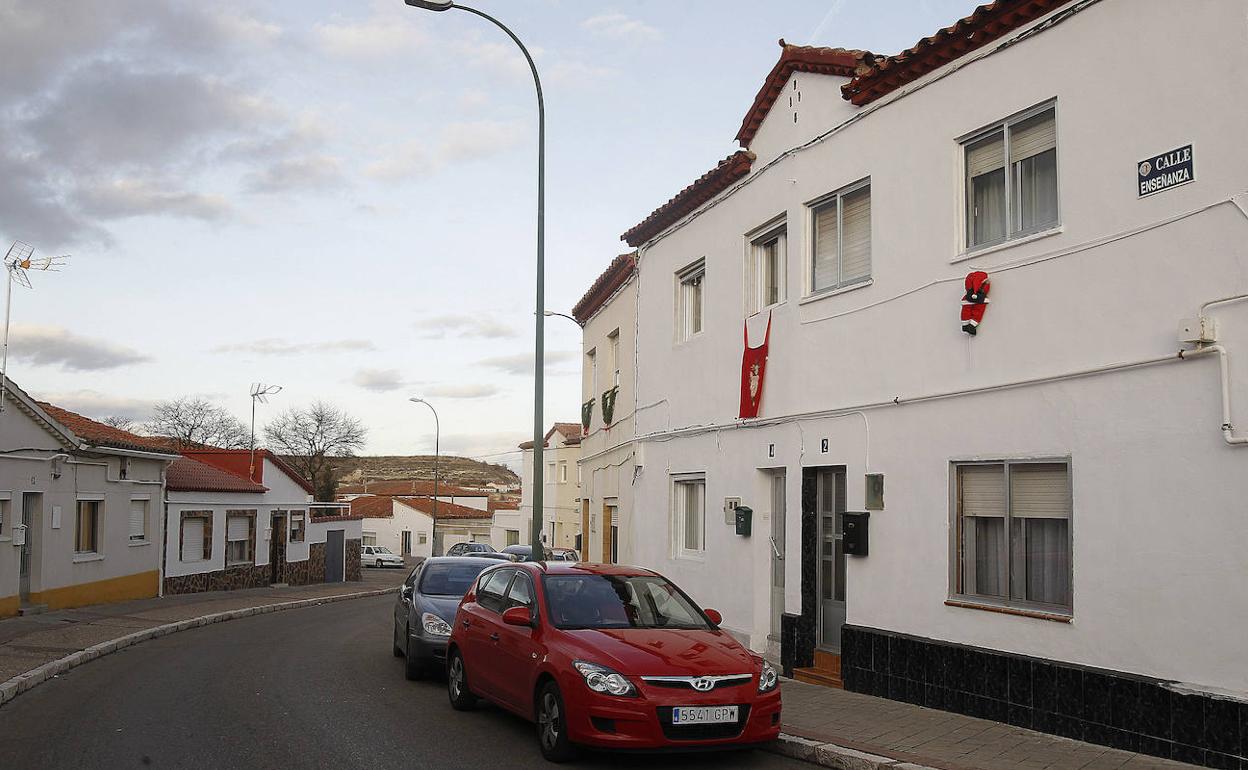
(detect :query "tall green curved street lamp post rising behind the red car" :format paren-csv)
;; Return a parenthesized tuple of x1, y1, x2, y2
(406, 0, 545, 562)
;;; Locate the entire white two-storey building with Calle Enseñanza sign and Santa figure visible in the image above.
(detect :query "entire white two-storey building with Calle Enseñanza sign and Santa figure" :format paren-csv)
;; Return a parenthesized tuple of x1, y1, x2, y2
(625, 0, 1248, 766)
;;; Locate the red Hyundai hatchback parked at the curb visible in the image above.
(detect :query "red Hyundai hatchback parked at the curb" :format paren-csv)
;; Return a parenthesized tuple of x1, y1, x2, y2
(447, 562, 780, 761)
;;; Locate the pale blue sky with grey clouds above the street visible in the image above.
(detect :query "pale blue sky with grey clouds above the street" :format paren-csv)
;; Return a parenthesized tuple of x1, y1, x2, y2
(0, 0, 975, 462)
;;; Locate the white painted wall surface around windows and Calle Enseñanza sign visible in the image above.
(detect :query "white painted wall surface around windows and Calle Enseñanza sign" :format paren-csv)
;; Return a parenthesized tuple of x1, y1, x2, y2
(634, 0, 1248, 691)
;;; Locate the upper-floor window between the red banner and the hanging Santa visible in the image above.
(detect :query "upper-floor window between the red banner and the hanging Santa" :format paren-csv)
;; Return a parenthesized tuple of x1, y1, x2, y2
(809, 180, 871, 295)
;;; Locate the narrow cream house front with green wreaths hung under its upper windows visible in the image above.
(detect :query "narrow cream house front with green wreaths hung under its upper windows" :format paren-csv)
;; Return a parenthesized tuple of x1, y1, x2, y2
(572, 253, 636, 564)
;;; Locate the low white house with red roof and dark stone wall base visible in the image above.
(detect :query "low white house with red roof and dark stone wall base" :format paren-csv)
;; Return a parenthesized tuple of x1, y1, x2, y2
(163, 449, 362, 594)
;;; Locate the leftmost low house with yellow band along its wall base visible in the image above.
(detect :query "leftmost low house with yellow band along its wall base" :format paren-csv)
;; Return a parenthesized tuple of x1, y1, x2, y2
(0, 379, 177, 616)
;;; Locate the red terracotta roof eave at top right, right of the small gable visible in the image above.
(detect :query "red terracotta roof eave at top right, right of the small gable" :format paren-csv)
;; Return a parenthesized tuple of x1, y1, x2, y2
(841, 0, 1073, 106)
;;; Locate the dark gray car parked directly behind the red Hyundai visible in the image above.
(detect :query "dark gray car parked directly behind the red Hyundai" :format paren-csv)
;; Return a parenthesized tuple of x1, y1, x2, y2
(393, 557, 498, 679)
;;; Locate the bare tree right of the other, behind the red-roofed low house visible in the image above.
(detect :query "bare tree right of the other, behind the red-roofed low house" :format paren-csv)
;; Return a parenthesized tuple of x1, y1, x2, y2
(265, 401, 367, 502)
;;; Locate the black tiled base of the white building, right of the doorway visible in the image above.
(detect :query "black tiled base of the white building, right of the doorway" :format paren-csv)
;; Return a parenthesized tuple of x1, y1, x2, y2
(841, 625, 1248, 770)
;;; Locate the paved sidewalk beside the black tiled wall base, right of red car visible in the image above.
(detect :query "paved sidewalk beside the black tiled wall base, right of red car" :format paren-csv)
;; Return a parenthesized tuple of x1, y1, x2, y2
(775, 680, 1193, 770)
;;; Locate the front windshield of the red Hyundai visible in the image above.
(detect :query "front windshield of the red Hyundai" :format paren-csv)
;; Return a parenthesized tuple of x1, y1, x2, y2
(543, 575, 711, 630)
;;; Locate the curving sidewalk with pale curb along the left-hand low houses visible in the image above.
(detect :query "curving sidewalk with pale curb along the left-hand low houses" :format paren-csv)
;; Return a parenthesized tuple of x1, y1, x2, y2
(0, 568, 409, 684)
